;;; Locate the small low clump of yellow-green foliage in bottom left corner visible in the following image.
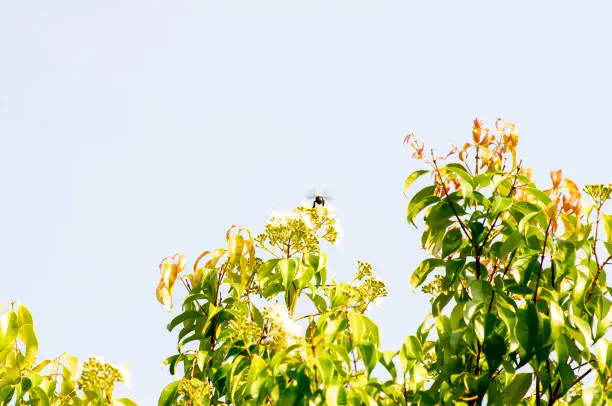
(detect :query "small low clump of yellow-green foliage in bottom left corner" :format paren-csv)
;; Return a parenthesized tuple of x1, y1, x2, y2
(0, 302, 136, 406)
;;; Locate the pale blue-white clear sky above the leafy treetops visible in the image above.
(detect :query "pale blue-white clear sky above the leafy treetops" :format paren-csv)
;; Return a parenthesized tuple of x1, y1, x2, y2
(0, 0, 612, 405)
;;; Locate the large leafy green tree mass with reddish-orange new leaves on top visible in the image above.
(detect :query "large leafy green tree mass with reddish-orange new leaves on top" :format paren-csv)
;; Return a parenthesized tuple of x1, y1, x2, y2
(157, 120, 612, 405)
